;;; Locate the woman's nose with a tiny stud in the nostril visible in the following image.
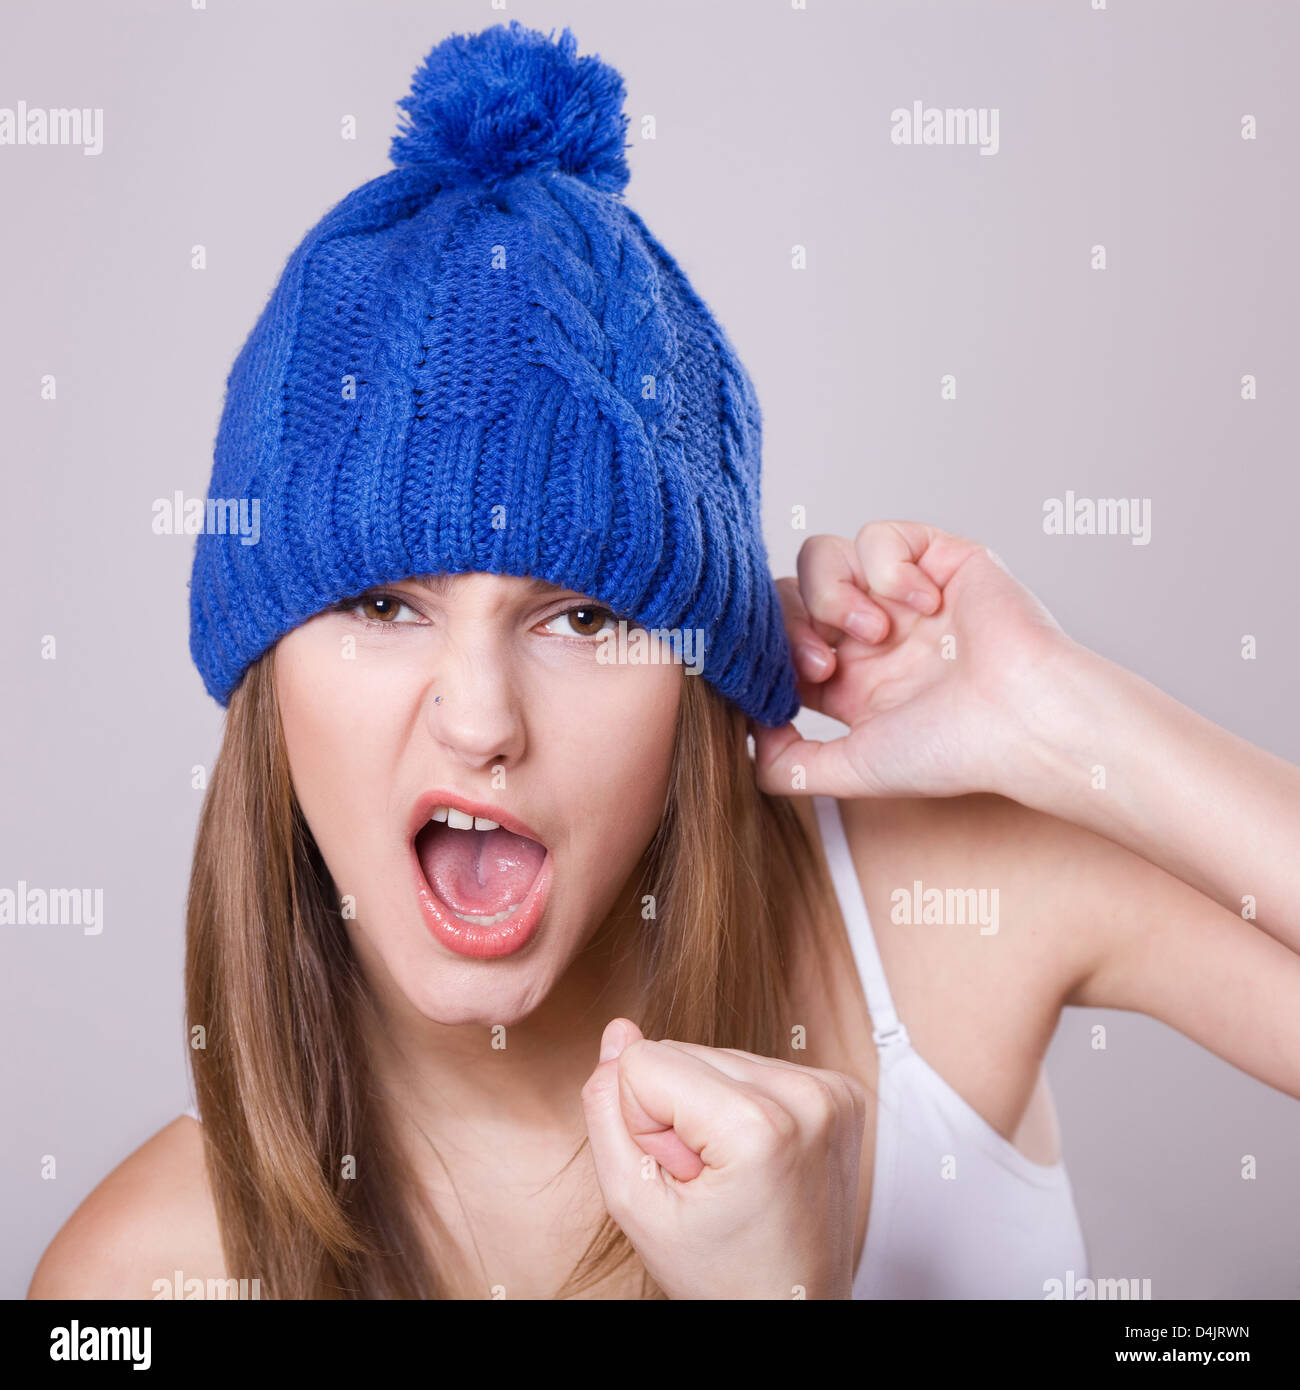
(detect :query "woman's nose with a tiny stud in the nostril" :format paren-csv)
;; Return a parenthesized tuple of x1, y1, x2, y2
(423, 644, 524, 771)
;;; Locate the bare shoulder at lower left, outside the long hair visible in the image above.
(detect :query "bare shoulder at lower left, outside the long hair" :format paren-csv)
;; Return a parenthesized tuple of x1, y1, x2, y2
(28, 1115, 225, 1298)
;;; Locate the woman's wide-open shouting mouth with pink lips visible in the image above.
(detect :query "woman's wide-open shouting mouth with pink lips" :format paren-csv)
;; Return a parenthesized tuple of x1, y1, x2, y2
(413, 805, 549, 956)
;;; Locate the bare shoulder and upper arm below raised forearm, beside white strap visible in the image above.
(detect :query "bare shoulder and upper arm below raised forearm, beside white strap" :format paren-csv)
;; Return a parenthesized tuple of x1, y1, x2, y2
(845, 795, 1300, 1106)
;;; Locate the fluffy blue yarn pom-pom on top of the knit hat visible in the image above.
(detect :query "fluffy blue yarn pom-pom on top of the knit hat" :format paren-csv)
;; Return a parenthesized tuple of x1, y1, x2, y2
(389, 19, 628, 193)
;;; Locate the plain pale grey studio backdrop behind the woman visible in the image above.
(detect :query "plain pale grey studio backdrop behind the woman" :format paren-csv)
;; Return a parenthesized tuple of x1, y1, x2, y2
(0, 0, 1300, 1297)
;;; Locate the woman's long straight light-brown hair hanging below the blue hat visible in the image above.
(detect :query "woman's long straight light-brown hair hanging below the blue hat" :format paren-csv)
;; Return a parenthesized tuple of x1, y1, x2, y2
(185, 653, 831, 1298)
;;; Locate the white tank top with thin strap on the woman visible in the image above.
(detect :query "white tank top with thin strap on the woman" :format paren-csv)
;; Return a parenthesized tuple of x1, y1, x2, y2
(813, 796, 1087, 1298)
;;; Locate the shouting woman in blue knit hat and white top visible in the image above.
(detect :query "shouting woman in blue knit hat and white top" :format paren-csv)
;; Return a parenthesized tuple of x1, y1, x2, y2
(32, 24, 1300, 1298)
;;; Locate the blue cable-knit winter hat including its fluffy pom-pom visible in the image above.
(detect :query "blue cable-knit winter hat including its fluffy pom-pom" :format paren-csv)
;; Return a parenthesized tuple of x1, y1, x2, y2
(190, 21, 798, 724)
